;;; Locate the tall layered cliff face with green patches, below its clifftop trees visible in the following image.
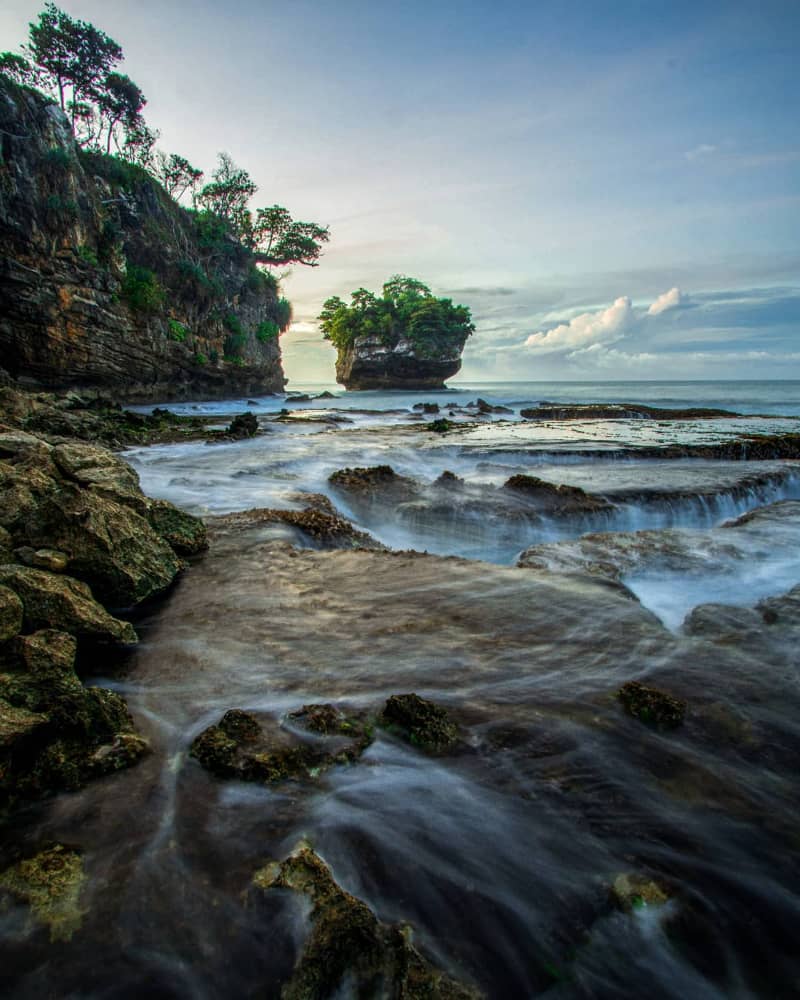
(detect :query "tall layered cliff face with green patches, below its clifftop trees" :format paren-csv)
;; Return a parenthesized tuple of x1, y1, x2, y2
(0, 76, 285, 401)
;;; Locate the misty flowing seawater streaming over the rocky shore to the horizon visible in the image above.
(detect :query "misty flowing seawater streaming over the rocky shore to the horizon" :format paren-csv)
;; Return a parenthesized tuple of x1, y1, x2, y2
(0, 383, 800, 1000)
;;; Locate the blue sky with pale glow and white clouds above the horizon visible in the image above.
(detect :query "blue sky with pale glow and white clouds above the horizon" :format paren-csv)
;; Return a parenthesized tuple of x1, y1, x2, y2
(0, 0, 800, 384)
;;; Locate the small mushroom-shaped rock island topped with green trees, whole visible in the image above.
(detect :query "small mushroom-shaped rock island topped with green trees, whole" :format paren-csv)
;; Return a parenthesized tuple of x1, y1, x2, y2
(319, 275, 475, 390)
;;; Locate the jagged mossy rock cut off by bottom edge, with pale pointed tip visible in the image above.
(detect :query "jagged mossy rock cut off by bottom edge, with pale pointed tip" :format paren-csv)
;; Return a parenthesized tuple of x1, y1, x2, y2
(253, 844, 481, 1000)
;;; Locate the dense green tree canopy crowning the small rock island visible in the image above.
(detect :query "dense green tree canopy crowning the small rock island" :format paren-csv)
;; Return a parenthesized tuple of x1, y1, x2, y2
(319, 275, 475, 358)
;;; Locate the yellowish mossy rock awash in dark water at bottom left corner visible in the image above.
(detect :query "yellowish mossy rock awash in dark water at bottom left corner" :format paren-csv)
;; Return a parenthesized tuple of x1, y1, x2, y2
(0, 844, 86, 942)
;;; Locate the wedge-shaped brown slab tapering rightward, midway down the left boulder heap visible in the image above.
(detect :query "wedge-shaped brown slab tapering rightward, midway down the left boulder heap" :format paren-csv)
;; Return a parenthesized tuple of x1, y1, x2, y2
(0, 565, 137, 643)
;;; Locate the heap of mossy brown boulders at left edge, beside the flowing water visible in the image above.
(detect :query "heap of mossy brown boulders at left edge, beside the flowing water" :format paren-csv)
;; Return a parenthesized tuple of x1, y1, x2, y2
(0, 402, 206, 808)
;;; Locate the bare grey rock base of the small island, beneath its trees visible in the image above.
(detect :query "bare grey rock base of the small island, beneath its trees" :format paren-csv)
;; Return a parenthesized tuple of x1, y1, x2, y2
(336, 337, 464, 390)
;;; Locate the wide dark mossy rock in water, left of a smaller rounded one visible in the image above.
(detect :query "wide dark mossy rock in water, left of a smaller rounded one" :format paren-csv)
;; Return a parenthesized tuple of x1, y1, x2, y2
(189, 705, 373, 783)
